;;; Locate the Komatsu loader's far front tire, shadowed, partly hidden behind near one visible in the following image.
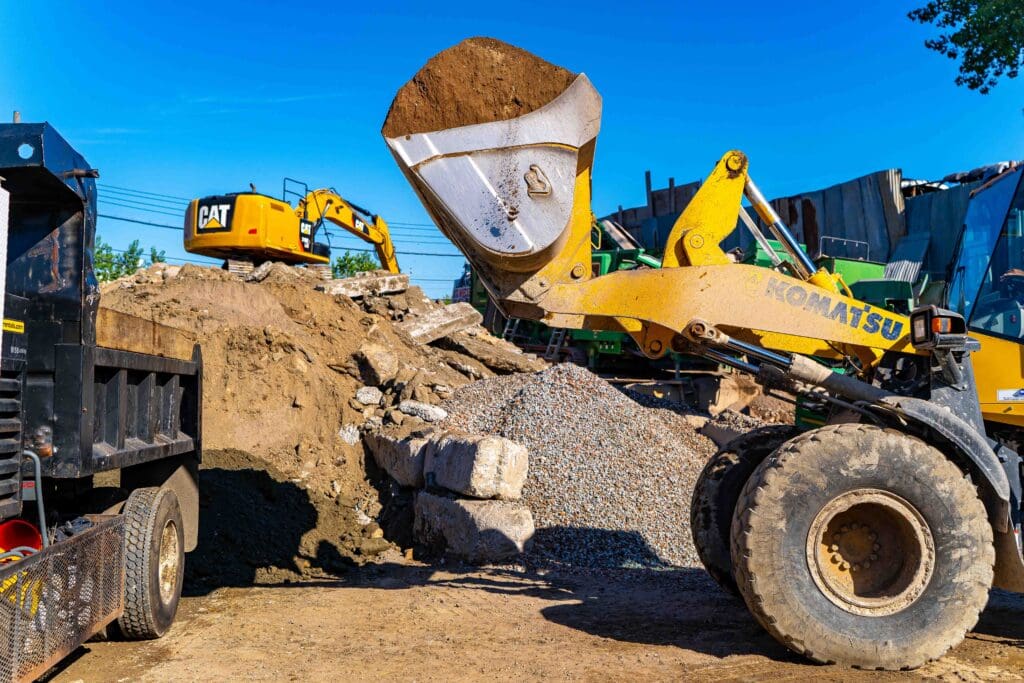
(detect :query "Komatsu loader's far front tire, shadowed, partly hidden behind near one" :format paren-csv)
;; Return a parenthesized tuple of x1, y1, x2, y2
(690, 425, 800, 595)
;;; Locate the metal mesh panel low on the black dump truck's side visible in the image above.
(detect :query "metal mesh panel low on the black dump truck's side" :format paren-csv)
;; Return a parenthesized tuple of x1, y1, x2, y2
(0, 515, 124, 683)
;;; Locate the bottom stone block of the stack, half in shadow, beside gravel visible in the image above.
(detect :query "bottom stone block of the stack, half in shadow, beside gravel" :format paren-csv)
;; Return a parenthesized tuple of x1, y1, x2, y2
(413, 492, 534, 564)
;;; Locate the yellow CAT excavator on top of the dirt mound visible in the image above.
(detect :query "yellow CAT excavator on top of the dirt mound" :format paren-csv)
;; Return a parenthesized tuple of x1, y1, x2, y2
(184, 178, 399, 273)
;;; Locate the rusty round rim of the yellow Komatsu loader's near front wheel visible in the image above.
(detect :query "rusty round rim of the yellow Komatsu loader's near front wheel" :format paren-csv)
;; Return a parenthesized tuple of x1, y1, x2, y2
(807, 488, 935, 616)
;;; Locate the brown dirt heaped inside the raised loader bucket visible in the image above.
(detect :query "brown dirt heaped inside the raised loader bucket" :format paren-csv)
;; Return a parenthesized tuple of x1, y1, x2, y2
(381, 38, 577, 137)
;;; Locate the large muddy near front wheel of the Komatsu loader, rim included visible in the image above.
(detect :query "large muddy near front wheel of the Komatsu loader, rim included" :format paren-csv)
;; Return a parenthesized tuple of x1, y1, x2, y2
(732, 424, 995, 670)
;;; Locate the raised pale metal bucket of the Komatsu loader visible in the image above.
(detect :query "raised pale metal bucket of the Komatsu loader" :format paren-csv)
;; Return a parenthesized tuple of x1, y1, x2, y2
(384, 39, 601, 272)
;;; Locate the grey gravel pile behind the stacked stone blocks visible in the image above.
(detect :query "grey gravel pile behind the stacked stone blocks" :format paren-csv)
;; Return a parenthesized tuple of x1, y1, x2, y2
(443, 364, 715, 567)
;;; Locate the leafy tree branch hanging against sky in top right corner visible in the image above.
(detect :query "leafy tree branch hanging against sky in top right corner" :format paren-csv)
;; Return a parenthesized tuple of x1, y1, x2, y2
(907, 0, 1024, 94)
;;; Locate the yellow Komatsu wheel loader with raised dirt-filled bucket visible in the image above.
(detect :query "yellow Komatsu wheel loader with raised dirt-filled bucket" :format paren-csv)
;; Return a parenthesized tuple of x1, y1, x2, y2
(385, 49, 1024, 670)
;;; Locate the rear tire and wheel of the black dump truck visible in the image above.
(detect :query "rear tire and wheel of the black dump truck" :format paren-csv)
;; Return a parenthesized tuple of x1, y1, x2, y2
(118, 487, 184, 640)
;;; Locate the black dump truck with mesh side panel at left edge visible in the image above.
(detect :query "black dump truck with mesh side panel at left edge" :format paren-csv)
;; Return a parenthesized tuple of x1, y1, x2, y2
(0, 123, 203, 681)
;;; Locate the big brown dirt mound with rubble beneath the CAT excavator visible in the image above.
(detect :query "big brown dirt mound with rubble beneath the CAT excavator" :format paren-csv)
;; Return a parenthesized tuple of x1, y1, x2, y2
(101, 264, 536, 585)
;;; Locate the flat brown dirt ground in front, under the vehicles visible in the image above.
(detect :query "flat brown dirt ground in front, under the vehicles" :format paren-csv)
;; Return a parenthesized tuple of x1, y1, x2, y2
(48, 564, 1024, 683)
